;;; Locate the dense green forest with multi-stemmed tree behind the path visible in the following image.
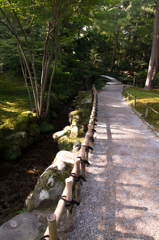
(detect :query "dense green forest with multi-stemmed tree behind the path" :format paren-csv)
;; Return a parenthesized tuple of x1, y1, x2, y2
(0, 0, 159, 124)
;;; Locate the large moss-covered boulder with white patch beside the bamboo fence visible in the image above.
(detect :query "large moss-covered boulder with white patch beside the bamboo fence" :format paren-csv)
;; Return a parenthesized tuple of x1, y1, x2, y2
(28, 165, 70, 210)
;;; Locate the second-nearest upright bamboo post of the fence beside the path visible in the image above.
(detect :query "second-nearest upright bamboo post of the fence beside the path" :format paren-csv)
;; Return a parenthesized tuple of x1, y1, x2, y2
(65, 177, 74, 232)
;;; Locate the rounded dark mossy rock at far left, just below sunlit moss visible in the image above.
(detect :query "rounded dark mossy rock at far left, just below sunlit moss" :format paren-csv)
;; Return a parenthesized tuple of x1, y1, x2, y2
(6, 132, 27, 148)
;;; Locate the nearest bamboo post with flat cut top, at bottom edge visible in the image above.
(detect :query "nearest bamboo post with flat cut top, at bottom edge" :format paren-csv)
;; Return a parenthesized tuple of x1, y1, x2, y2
(47, 213, 57, 240)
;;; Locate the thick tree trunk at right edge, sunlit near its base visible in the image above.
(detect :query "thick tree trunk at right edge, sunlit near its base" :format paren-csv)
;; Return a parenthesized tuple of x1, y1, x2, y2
(144, 0, 159, 90)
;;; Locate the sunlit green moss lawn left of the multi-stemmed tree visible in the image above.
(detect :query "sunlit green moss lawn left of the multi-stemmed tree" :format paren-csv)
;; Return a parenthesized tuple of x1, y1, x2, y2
(0, 76, 30, 128)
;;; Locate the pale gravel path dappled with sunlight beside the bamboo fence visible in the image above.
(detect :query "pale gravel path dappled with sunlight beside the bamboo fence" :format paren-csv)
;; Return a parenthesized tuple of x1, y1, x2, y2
(67, 85, 159, 240)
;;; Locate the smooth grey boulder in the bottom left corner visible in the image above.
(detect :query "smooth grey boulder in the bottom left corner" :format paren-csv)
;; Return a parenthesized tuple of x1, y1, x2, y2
(0, 212, 39, 240)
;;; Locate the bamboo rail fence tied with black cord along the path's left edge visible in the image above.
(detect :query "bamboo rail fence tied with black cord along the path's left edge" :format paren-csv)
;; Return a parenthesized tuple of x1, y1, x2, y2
(42, 86, 98, 240)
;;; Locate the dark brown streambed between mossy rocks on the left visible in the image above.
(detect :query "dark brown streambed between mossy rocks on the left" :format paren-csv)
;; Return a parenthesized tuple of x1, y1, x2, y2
(0, 103, 71, 225)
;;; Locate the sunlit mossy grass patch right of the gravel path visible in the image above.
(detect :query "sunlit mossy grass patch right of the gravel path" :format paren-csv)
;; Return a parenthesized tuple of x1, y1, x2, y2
(125, 87, 159, 130)
